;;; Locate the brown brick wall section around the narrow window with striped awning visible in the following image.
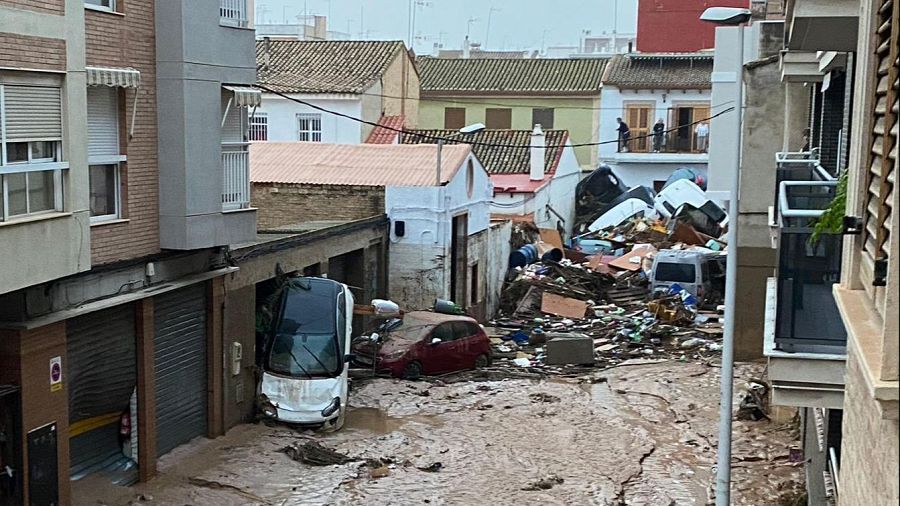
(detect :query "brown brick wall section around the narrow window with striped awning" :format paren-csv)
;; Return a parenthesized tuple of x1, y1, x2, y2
(85, 0, 159, 265)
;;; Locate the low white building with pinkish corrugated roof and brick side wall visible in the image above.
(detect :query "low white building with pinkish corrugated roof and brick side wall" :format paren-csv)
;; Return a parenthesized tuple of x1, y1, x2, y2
(251, 142, 509, 317)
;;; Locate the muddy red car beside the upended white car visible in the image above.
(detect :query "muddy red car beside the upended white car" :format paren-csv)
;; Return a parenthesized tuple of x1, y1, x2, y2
(353, 311, 491, 379)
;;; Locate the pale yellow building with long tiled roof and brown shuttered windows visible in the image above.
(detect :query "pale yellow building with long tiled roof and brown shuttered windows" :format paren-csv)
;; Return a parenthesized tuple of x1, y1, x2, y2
(416, 57, 607, 170)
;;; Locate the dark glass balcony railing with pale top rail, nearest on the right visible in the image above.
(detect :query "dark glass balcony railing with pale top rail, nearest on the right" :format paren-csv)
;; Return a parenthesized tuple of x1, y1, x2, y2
(775, 181, 847, 353)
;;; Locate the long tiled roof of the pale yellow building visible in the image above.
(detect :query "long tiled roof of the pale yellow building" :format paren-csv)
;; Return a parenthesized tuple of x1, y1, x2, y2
(416, 57, 606, 95)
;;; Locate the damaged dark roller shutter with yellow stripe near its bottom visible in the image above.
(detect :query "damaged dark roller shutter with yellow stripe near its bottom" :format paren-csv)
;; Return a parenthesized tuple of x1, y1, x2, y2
(66, 304, 137, 478)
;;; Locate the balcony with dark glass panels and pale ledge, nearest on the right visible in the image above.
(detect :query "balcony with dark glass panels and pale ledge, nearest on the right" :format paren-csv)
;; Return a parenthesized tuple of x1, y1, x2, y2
(764, 166, 847, 409)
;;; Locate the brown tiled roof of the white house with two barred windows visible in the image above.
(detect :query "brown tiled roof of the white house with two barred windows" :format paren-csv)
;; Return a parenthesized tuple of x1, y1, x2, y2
(256, 40, 404, 93)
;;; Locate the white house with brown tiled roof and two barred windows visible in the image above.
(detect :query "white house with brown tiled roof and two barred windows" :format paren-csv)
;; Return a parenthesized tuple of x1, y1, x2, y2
(250, 39, 419, 144)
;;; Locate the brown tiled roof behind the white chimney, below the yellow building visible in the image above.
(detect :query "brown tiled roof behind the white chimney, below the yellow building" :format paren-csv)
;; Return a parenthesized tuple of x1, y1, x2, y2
(400, 130, 569, 174)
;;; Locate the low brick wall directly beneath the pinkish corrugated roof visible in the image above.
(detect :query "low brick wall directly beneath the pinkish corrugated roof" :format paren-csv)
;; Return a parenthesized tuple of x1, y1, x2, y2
(250, 183, 384, 230)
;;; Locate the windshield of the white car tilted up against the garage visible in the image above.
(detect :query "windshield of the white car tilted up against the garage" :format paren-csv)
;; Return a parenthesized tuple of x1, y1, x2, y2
(268, 333, 341, 378)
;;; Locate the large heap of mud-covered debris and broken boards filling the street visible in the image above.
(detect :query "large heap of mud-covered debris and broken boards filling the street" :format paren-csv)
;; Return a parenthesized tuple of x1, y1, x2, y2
(488, 214, 724, 370)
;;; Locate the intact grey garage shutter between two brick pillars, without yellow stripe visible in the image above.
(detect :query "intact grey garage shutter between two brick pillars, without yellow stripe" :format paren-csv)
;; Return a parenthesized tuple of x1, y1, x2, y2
(154, 284, 207, 455)
